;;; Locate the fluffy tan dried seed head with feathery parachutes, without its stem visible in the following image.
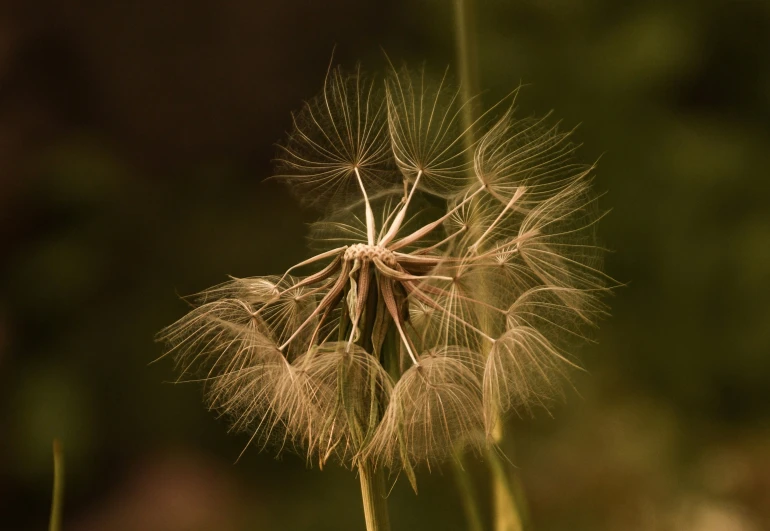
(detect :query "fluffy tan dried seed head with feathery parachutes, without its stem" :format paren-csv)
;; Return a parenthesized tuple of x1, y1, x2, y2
(159, 62, 608, 478)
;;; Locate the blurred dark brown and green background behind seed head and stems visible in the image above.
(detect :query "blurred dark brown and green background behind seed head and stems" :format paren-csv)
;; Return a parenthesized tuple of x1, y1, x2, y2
(0, 0, 770, 531)
